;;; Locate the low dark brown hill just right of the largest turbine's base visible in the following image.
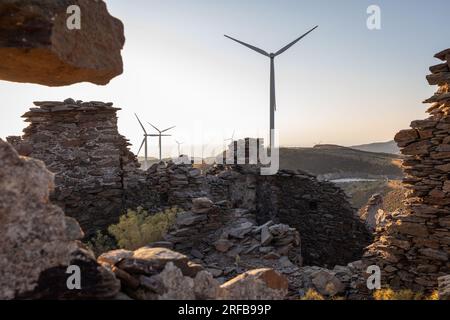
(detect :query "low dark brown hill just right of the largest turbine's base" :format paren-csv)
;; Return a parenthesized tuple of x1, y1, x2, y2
(280, 145, 403, 180)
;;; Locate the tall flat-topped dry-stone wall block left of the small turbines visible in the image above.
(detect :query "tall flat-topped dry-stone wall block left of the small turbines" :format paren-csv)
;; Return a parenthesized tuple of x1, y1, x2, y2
(11, 99, 144, 235)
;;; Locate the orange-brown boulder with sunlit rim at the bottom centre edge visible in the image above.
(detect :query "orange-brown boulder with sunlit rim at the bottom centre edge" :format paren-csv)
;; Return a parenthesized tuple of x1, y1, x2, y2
(219, 269, 288, 300)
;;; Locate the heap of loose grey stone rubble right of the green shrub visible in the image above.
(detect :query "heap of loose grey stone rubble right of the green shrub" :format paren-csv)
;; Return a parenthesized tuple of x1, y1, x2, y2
(146, 198, 302, 282)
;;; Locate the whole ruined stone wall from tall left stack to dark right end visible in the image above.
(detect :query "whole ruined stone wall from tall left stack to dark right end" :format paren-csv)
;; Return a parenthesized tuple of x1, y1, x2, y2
(8, 99, 370, 267)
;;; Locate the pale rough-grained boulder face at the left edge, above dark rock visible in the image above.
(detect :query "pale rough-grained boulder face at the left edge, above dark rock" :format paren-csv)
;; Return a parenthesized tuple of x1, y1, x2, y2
(0, 140, 76, 299)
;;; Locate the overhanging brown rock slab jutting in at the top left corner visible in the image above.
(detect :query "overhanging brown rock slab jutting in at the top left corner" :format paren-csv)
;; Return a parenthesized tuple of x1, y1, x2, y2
(0, 0, 125, 86)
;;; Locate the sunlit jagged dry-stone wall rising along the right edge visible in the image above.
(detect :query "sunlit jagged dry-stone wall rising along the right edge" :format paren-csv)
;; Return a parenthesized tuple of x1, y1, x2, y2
(367, 49, 450, 290)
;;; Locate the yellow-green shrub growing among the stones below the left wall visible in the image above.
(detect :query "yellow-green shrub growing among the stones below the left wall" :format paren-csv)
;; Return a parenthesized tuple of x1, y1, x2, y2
(108, 207, 179, 250)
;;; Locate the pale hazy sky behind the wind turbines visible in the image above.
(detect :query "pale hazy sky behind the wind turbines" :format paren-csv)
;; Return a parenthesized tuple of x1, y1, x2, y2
(0, 0, 450, 156)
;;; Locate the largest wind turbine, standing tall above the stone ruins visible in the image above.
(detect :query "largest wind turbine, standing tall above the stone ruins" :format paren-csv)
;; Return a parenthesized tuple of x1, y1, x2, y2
(225, 26, 318, 149)
